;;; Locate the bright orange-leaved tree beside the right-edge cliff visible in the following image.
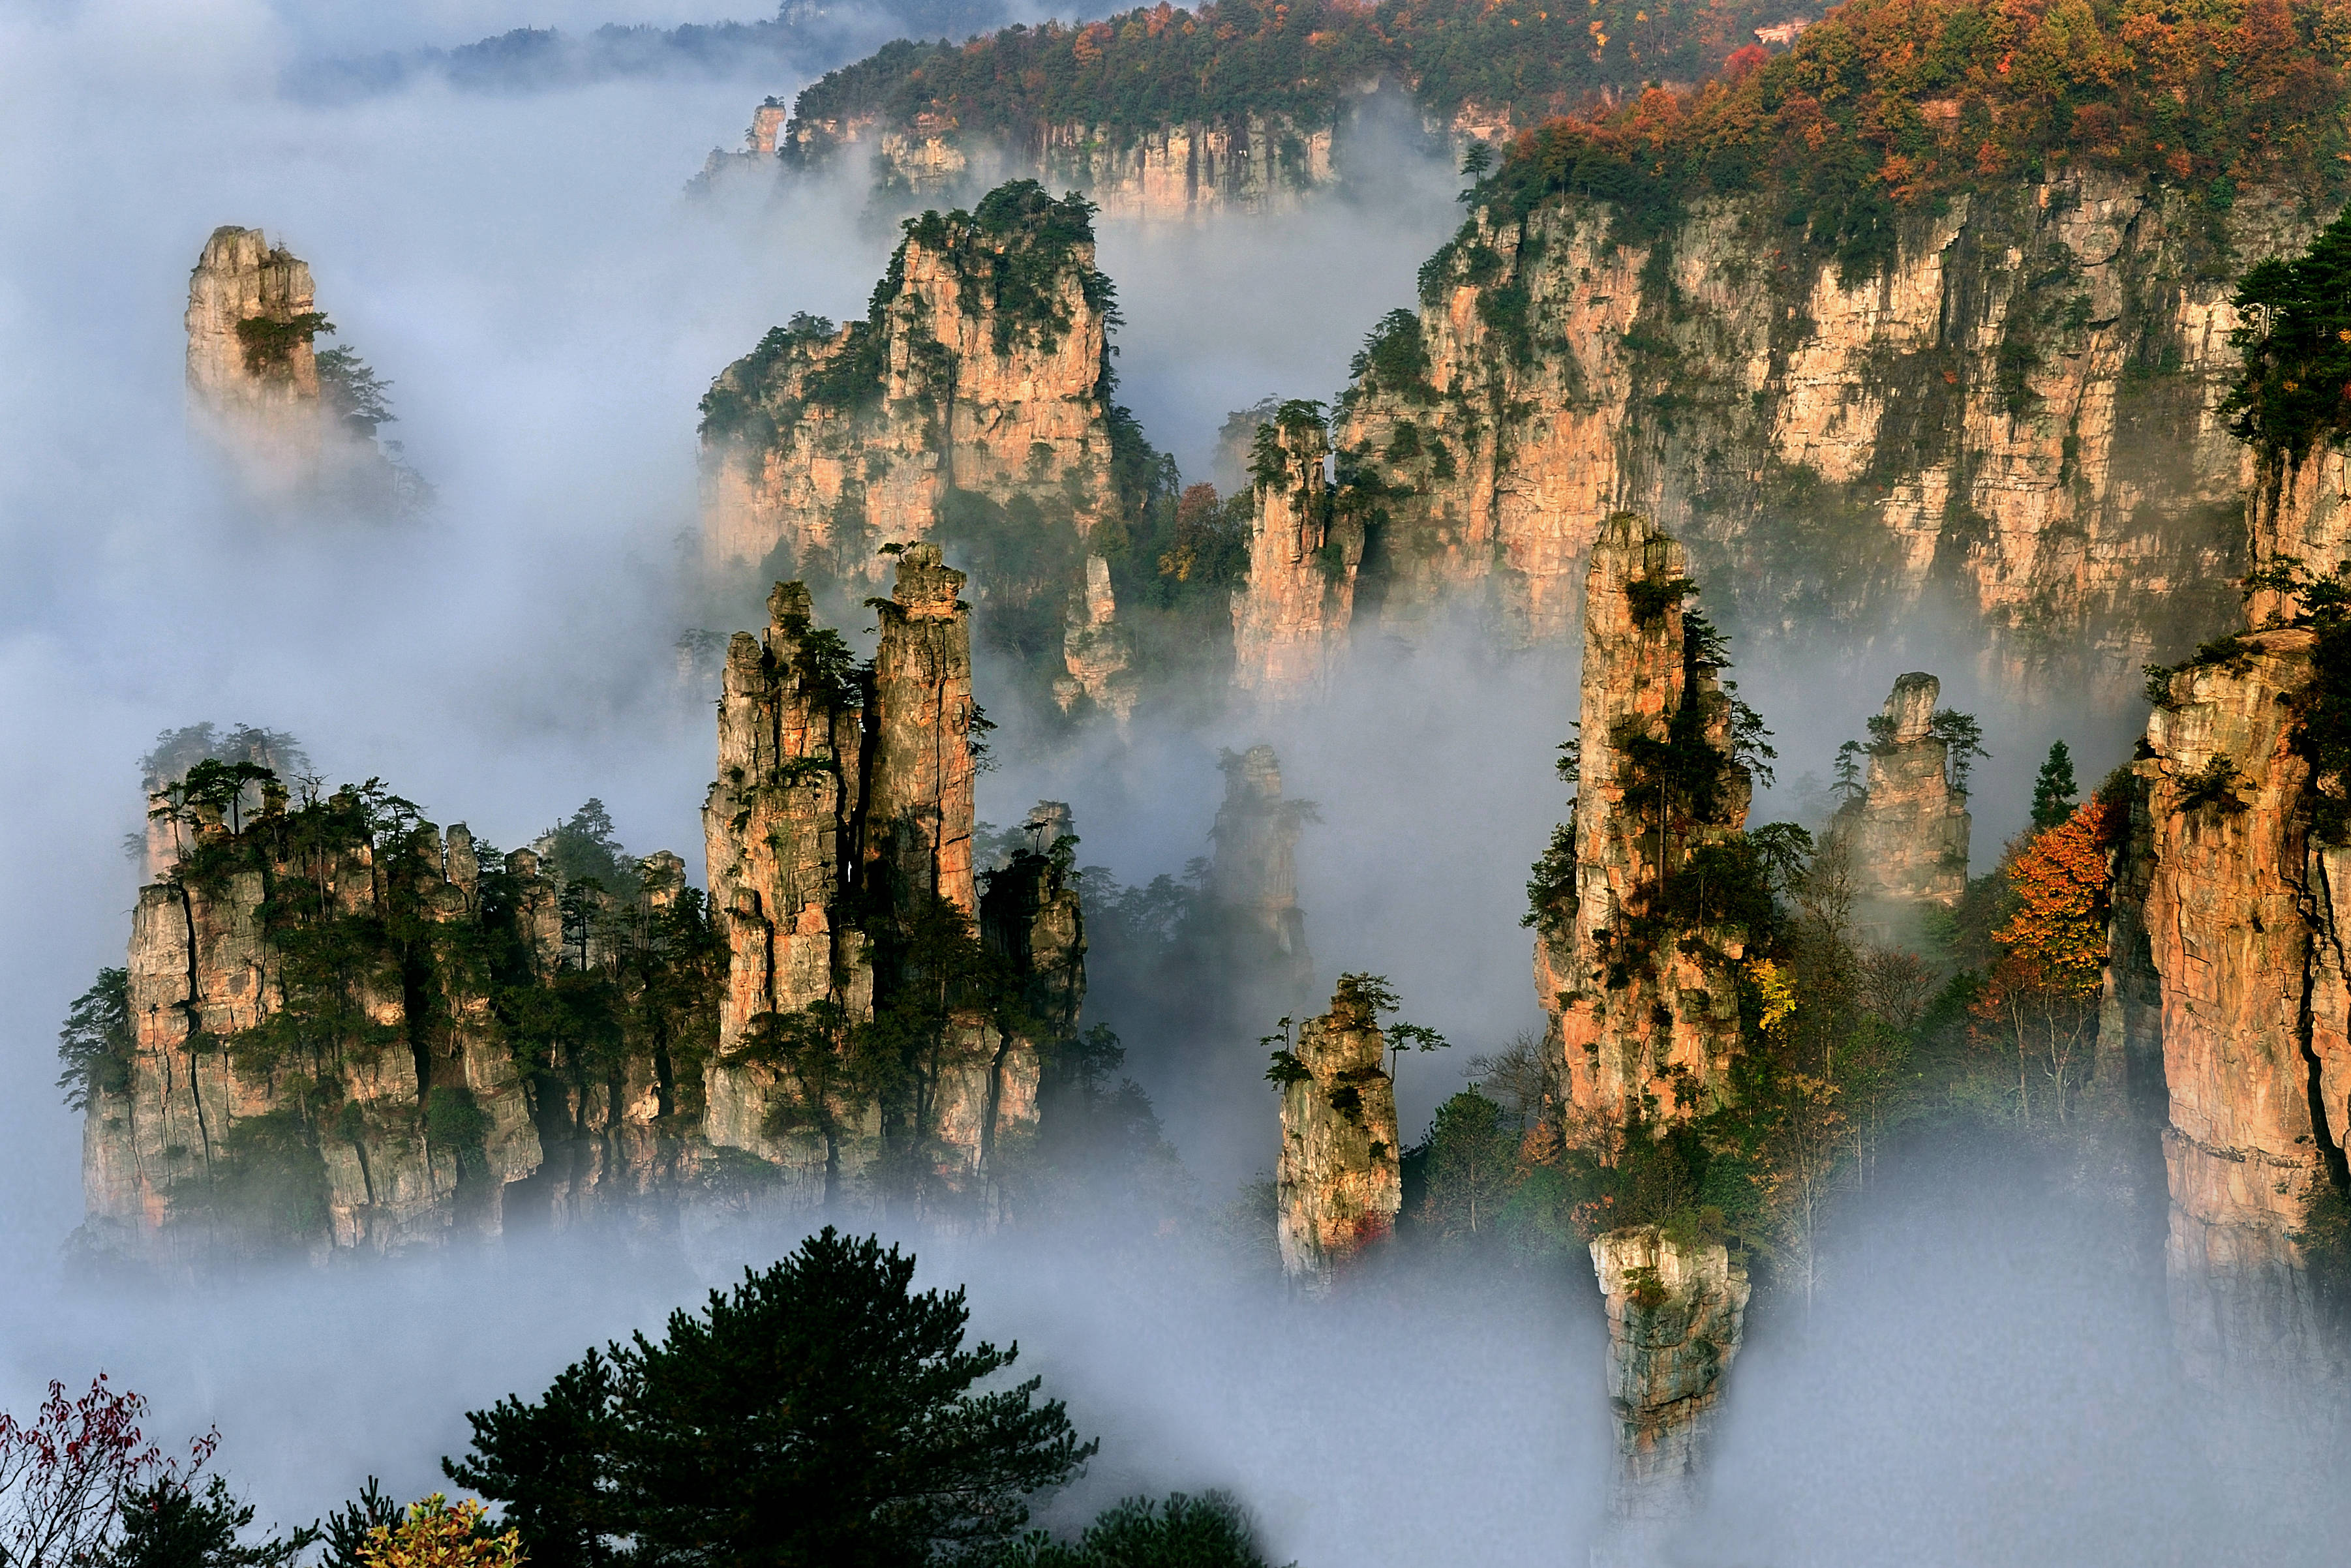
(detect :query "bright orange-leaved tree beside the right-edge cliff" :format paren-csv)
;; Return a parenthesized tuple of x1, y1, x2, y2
(1975, 799, 2118, 1121)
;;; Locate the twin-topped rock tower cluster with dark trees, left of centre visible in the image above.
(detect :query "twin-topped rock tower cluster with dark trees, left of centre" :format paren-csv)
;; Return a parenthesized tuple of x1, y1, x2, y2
(703, 543, 1084, 1220)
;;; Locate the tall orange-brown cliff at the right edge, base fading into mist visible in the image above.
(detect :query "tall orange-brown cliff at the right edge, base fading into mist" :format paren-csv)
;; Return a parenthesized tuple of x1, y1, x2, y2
(2137, 627, 2351, 1387)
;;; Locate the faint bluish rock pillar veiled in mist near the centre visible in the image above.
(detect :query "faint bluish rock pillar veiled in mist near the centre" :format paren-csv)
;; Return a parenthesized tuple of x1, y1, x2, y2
(1199, 746, 1316, 1018)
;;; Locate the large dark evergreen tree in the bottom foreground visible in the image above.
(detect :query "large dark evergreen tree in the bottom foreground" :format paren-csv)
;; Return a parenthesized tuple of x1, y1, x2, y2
(442, 1225, 1095, 1568)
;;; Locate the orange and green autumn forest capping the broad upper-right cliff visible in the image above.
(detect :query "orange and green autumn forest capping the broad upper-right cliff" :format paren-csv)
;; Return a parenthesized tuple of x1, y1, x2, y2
(1432, 0, 2351, 273)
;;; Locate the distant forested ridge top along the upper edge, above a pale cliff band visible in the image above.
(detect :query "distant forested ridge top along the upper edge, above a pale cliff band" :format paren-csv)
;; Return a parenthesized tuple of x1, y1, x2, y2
(787, 0, 1813, 153)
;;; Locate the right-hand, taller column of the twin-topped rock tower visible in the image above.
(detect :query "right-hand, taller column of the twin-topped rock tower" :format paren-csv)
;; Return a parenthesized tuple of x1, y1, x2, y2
(865, 543, 978, 914)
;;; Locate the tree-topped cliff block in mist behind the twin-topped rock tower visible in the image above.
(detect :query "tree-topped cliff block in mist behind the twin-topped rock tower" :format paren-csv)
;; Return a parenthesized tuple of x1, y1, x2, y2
(703, 186, 1117, 585)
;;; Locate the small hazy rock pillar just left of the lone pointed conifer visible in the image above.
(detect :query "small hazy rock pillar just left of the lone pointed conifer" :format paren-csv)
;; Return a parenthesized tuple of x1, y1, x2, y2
(1832, 672, 1970, 907)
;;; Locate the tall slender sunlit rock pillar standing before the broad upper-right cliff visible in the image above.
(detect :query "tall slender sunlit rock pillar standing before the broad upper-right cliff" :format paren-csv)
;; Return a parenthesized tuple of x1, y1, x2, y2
(1535, 513, 1752, 1147)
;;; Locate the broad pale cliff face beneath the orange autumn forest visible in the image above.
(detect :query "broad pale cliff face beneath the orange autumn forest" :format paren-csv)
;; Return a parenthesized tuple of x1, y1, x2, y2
(1246, 172, 2309, 698)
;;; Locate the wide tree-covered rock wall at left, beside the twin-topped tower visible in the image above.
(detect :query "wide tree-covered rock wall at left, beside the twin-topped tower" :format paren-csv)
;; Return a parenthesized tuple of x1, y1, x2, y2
(82, 799, 701, 1267)
